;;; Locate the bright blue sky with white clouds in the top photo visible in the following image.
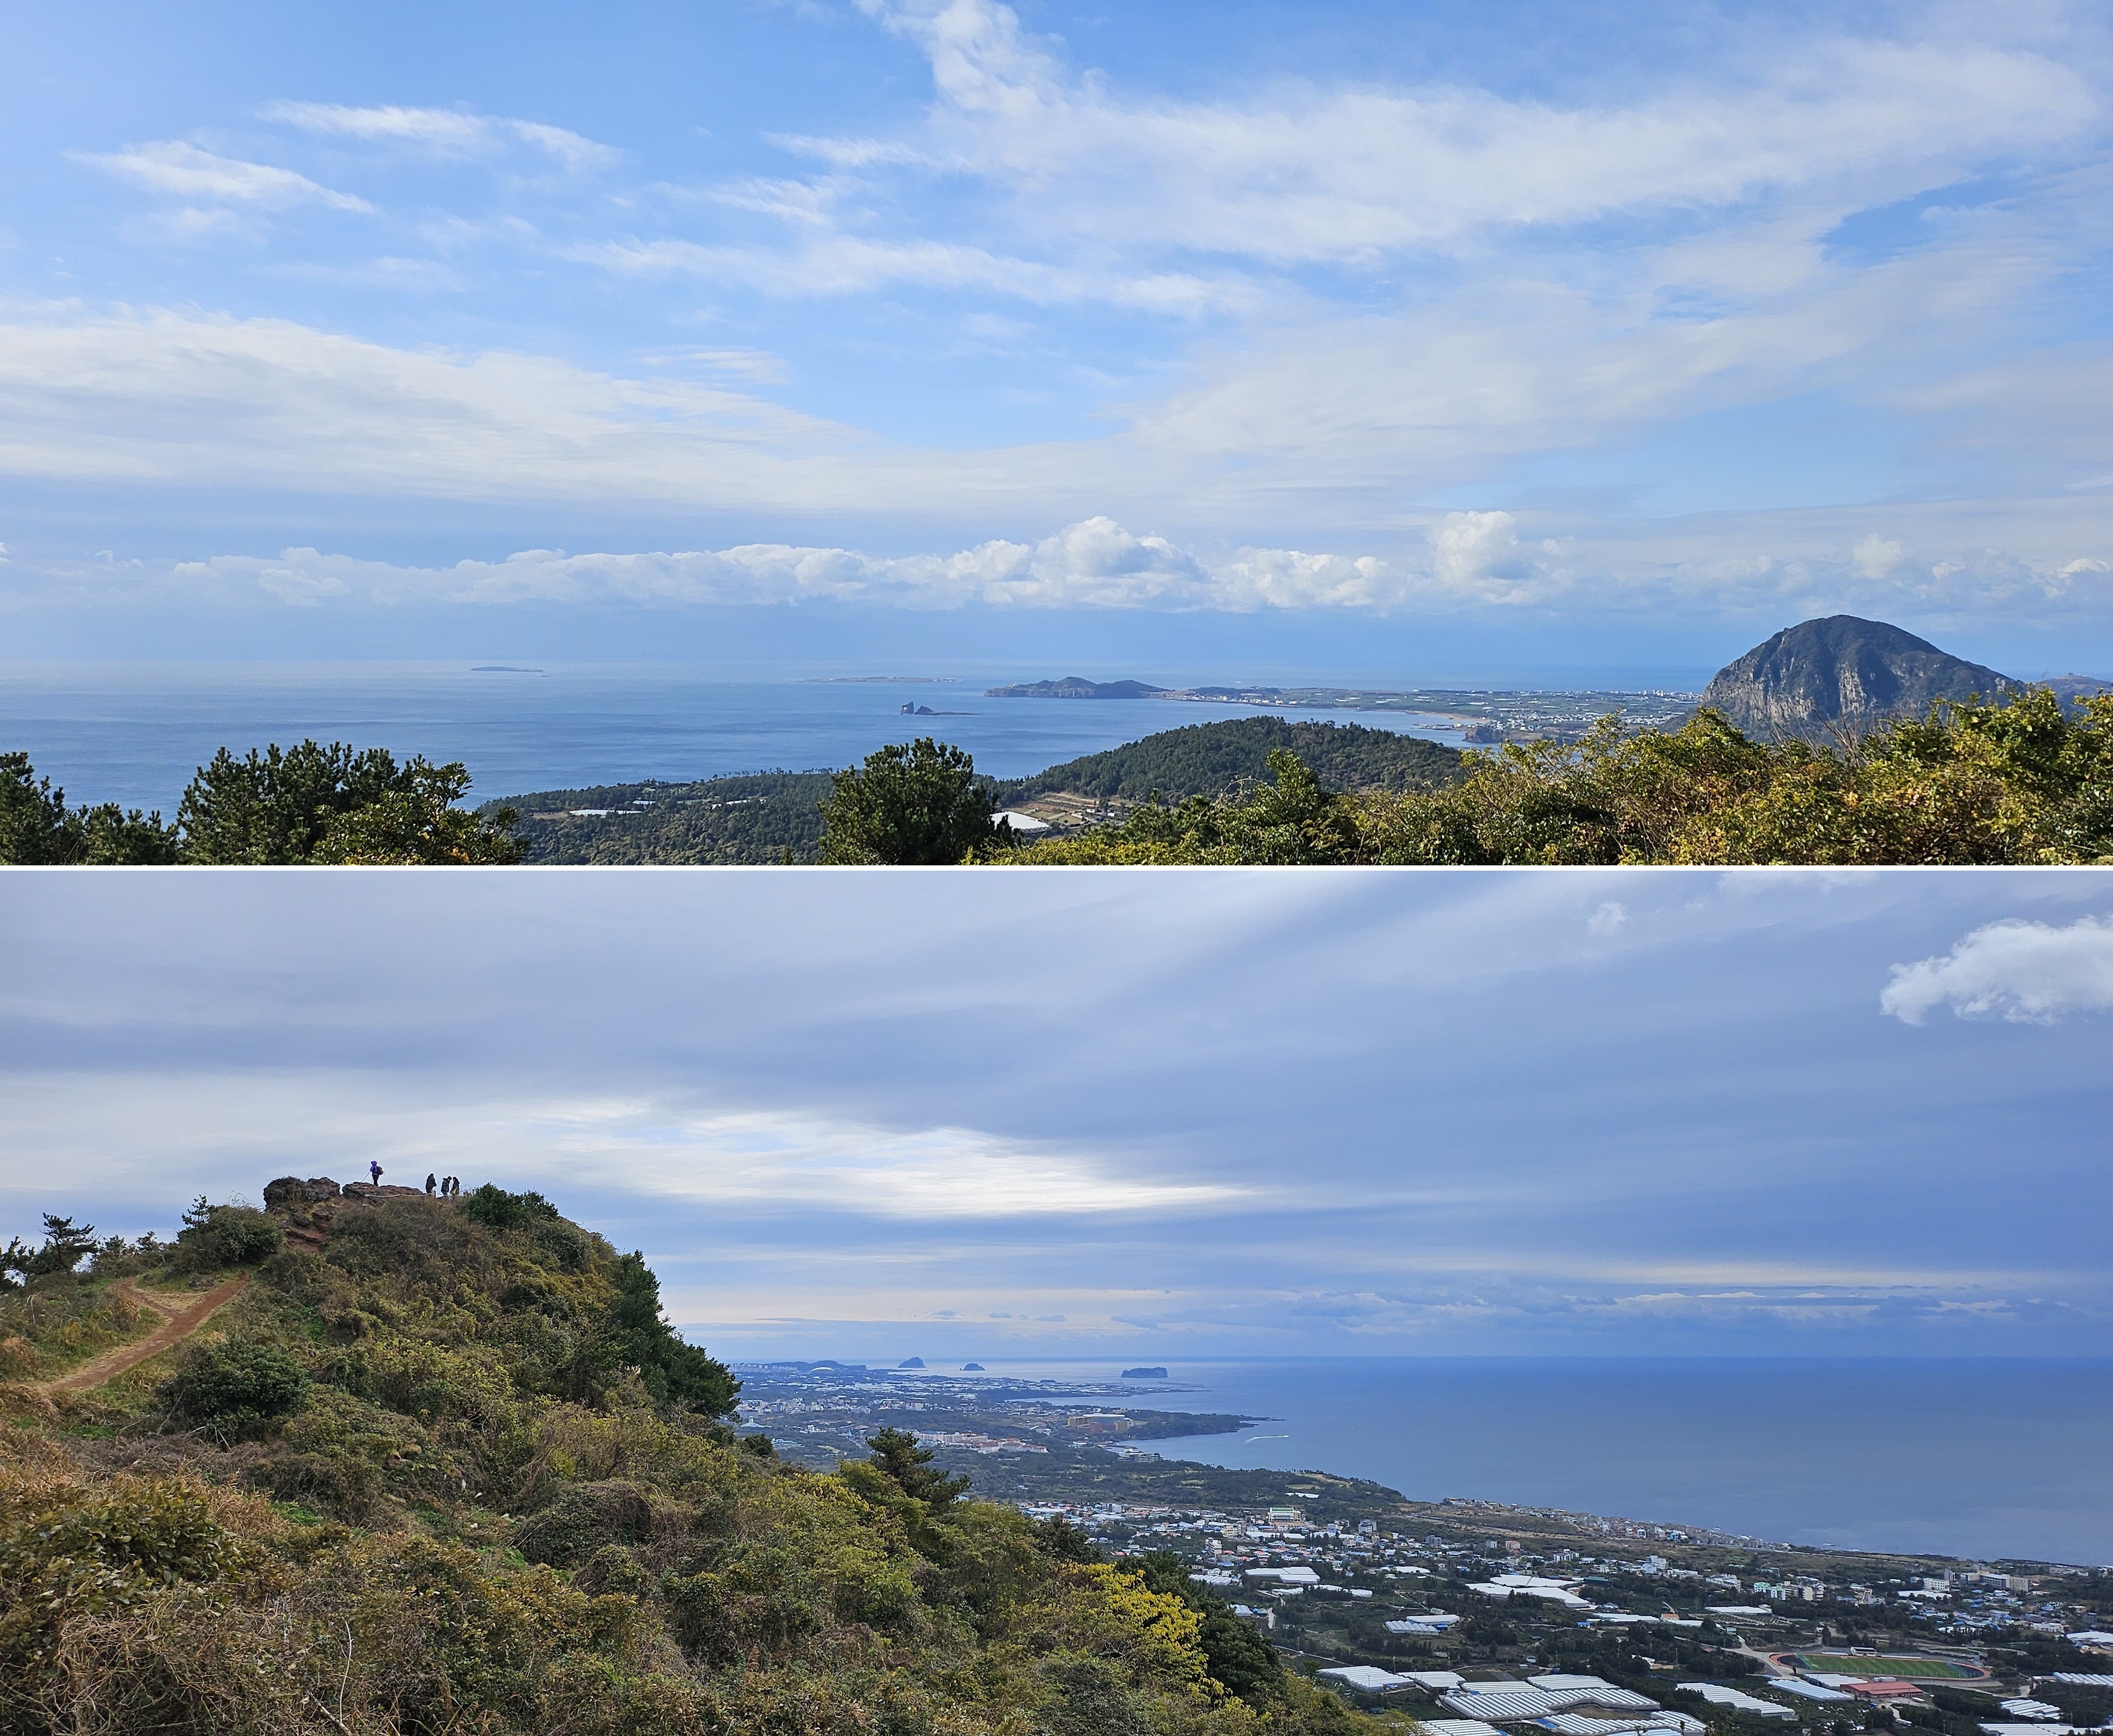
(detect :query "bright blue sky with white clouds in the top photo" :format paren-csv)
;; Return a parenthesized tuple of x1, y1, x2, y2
(0, 0, 2113, 676)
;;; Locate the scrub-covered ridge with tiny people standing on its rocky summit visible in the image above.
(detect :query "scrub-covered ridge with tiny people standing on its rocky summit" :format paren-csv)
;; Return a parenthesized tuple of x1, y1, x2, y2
(0, 1179, 1365, 1736)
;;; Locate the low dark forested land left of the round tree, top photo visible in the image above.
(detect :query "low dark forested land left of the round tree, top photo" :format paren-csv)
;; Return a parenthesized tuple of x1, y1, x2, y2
(490, 771, 828, 864)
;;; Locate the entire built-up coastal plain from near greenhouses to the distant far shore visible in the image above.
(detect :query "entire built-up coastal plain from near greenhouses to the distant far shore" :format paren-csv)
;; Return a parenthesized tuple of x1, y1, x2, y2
(740, 1358, 2113, 1736)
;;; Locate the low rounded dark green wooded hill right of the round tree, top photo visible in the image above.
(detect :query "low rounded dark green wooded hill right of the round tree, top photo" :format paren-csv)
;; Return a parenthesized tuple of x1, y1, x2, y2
(999, 718, 1466, 802)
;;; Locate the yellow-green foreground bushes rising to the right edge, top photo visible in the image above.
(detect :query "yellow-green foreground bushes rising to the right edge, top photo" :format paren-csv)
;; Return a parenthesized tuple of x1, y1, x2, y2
(997, 688, 2113, 866)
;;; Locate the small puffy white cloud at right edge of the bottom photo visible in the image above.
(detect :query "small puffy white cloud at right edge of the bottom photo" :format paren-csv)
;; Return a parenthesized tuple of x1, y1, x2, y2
(1878, 917, 2113, 1024)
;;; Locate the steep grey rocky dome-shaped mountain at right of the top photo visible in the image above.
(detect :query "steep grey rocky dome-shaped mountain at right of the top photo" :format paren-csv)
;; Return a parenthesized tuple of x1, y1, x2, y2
(1703, 614, 2022, 737)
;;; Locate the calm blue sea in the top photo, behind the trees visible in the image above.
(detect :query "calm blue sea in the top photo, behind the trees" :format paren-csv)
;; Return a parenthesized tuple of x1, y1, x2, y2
(0, 663, 1488, 813)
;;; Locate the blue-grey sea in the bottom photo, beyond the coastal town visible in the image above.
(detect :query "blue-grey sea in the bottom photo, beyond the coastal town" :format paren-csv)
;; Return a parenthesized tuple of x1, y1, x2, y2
(951, 1358, 2113, 1565)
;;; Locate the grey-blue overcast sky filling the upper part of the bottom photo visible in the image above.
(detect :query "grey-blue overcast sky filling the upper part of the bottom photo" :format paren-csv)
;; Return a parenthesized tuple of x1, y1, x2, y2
(0, 870, 2113, 1360)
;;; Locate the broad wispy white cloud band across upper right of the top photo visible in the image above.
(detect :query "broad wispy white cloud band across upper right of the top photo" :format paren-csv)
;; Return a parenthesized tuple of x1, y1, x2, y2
(820, 0, 2098, 264)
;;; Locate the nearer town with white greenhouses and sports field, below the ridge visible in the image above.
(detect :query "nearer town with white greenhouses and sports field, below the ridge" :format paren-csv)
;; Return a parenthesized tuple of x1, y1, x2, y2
(1023, 1478, 2113, 1736)
